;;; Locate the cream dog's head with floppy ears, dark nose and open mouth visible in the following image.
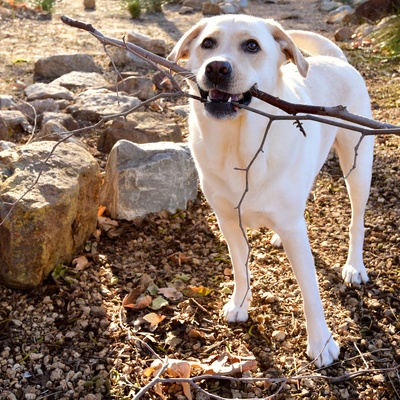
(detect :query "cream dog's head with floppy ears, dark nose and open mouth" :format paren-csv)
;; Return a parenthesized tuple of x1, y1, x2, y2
(168, 15, 308, 119)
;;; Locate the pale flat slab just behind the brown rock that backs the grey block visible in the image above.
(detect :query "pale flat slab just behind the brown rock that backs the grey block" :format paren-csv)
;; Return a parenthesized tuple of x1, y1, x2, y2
(66, 89, 140, 122)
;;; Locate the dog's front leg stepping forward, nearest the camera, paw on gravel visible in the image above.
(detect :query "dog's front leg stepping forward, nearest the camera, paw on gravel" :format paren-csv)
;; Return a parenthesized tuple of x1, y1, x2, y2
(278, 220, 339, 367)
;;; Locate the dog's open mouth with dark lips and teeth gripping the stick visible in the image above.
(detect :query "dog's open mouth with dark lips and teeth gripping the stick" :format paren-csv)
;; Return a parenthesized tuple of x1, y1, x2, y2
(199, 87, 252, 119)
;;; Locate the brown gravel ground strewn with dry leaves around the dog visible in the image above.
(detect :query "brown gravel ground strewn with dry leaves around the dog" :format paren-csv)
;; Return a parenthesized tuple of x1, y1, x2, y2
(0, 0, 400, 400)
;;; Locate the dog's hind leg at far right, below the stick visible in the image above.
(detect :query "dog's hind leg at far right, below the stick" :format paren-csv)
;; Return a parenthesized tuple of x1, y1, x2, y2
(335, 132, 374, 283)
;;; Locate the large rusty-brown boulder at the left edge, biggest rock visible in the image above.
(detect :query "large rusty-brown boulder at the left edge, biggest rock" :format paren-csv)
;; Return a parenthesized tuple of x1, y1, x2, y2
(0, 142, 100, 289)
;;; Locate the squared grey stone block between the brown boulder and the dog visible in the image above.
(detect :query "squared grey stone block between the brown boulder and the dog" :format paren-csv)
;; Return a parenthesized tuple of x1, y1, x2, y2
(100, 140, 197, 220)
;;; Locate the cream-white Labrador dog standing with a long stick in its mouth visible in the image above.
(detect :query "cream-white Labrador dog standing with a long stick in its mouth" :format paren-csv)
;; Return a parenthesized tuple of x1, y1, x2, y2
(168, 15, 374, 367)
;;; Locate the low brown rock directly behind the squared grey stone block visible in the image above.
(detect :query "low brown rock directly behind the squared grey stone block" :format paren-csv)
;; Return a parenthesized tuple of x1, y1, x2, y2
(97, 112, 182, 153)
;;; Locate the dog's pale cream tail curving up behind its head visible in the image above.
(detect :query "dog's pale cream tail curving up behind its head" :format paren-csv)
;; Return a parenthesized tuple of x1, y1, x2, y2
(287, 30, 348, 62)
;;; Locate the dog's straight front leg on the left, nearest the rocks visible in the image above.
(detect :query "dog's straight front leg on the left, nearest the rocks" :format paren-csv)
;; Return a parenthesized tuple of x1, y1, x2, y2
(219, 220, 251, 322)
